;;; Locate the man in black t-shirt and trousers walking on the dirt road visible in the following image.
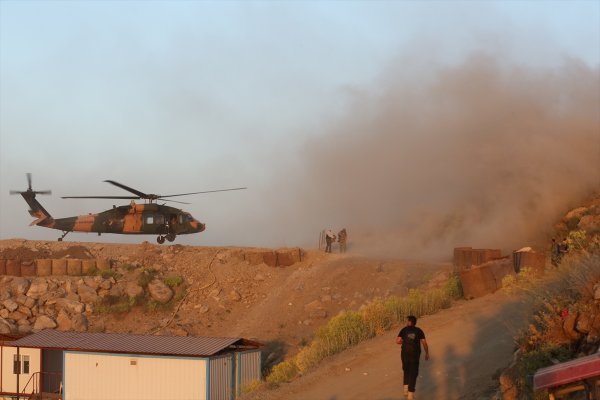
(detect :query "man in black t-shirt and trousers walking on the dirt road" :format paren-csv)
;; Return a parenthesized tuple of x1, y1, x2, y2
(396, 315, 429, 400)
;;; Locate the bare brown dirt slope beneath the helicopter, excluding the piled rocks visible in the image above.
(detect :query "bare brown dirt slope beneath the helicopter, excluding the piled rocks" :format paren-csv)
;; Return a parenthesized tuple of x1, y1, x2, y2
(0, 239, 451, 353)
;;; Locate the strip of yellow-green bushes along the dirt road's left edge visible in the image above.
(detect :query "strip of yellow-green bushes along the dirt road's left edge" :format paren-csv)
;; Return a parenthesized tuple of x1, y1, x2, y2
(267, 276, 462, 384)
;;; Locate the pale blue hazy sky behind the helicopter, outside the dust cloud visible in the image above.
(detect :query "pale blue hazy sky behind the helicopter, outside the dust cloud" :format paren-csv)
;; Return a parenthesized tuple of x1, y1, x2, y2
(0, 0, 600, 256)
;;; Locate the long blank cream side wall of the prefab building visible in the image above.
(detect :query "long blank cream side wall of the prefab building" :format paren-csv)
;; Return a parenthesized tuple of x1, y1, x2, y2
(63, 351, 208, 400)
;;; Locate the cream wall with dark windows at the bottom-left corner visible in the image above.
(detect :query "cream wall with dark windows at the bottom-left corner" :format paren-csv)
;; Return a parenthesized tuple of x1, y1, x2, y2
(0, 345, 41, 393)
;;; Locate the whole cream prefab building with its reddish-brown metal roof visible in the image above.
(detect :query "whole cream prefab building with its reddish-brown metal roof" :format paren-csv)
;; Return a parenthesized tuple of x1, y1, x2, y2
(0, 329, 262, 400)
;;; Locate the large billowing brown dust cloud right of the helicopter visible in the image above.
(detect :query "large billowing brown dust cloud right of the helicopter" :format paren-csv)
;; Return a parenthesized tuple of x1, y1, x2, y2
(271, 53, 600, 259)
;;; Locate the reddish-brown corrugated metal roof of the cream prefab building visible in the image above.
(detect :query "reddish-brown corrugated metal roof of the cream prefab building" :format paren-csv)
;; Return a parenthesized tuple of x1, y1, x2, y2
(9, 329, 261, 357)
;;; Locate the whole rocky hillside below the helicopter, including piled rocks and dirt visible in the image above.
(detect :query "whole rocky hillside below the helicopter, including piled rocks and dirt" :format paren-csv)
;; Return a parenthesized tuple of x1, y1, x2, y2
(0, 239, 451, 352)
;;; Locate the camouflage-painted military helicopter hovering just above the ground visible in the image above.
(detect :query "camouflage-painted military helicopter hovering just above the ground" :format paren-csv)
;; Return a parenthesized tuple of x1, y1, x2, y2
(10, 173, 246, 244)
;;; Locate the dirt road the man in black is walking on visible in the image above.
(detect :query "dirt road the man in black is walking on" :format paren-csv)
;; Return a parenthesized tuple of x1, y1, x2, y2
(246, 293, 529, 400)
